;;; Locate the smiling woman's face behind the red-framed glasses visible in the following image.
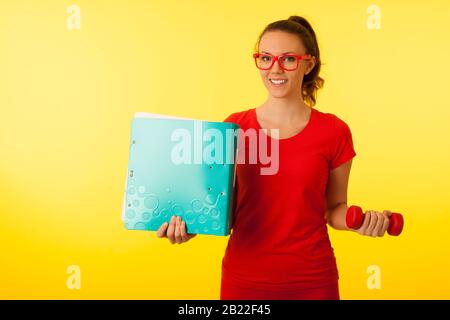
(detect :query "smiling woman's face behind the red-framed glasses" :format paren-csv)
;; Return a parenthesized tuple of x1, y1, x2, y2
(259, 31, 315, 98)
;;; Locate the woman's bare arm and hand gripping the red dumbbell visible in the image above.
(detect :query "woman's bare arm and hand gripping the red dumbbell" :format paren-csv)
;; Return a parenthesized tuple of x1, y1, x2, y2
(326, 159, 391, 237)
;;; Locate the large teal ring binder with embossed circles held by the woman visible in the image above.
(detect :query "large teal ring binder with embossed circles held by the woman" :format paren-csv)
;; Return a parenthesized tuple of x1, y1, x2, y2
(122, 112, 239, 236)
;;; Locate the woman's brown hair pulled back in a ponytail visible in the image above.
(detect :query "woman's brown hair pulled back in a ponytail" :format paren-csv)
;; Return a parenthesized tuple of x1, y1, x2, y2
(255, 16, 325, 106)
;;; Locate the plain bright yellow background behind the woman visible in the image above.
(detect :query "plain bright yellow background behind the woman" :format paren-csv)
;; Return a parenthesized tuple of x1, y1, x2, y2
(0, 0, 450, 299)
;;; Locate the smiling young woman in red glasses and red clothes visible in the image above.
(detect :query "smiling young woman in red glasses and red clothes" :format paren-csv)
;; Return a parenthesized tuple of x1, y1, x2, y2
(157, 16, 391, 300)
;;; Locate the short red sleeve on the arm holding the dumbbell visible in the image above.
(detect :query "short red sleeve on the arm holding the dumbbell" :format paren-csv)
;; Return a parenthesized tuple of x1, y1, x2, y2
(330, 116, 356, 169)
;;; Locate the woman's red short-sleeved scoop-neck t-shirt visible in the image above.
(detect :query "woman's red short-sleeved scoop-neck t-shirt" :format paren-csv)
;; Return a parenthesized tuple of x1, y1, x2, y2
(222, 108, 356, 290)
